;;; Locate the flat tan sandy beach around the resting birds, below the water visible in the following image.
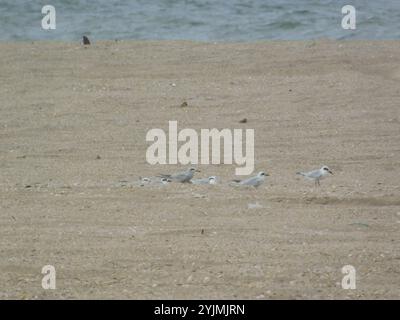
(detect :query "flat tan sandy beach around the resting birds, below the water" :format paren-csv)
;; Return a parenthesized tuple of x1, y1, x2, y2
(0, 40, 400, 299)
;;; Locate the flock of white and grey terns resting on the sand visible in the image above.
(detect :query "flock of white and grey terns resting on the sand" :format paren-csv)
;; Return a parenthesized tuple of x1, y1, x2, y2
(123, 166, 333, 188)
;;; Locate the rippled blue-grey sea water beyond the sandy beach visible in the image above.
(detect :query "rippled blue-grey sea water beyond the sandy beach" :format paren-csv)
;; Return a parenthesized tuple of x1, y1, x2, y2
(0, 0, 400, 41)
